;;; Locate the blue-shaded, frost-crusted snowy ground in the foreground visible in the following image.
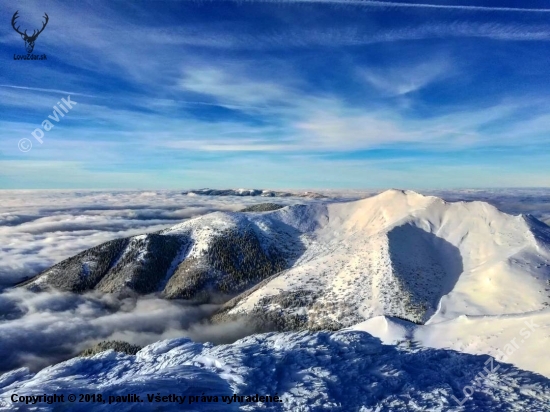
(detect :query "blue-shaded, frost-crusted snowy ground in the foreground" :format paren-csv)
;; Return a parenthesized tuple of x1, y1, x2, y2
(0, 331, 550, 412)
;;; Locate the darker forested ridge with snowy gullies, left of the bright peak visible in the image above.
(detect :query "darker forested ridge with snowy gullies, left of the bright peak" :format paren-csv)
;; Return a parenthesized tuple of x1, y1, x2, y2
(22, 206, 303, 301)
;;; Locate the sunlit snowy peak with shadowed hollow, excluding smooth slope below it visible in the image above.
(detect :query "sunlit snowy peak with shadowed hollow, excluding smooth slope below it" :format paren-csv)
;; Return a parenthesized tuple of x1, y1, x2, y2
(224, 190, 550, 328)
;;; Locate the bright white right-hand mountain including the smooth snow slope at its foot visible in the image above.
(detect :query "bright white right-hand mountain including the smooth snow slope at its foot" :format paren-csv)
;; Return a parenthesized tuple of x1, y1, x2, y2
(212, 190, 550, 377)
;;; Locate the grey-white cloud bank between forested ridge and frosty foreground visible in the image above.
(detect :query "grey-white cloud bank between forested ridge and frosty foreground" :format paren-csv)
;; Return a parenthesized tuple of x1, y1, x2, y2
(0, 289, 260, 372)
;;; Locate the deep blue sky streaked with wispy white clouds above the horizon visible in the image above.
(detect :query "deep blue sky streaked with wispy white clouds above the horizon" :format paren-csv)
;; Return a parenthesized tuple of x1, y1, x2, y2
(0, 0, 550, 189)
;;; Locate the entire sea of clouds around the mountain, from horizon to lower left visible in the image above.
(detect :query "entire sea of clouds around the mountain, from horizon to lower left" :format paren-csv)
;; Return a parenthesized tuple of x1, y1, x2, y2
(0, 189, 550, 372)
